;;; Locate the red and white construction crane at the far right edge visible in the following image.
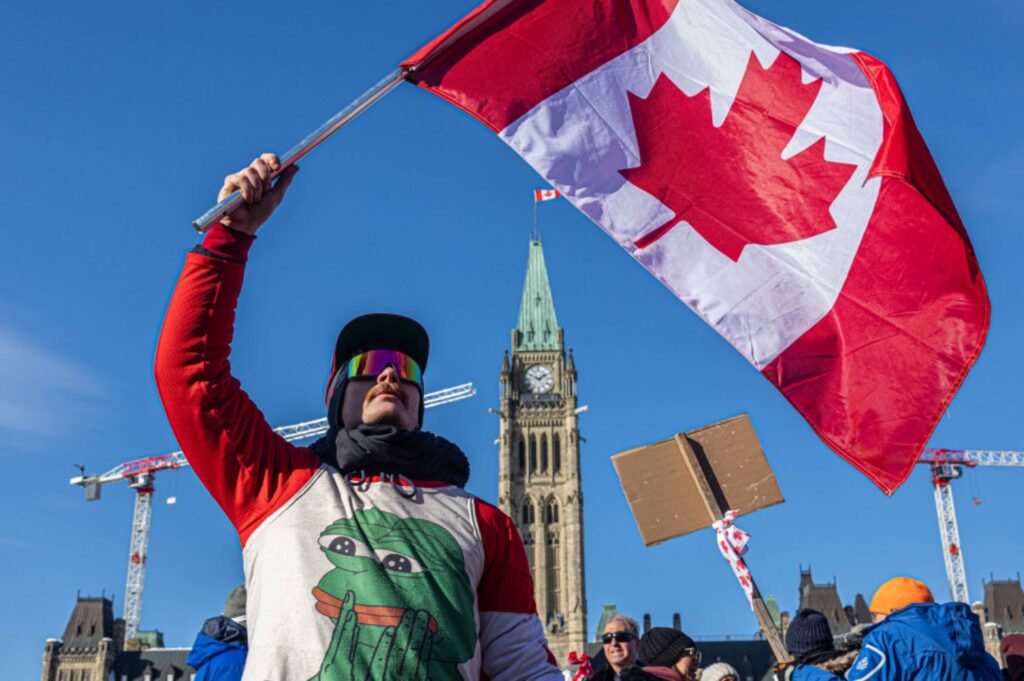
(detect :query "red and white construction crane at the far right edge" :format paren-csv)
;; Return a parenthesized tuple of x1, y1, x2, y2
(918, 450, 1024, 603)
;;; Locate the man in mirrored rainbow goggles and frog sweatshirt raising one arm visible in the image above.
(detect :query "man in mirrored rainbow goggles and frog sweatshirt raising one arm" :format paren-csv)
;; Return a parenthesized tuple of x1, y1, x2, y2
(156, 154, 562, 681)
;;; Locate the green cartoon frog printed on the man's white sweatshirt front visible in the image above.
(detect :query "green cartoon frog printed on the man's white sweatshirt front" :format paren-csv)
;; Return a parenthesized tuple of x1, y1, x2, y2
(312, 508, 476, 681)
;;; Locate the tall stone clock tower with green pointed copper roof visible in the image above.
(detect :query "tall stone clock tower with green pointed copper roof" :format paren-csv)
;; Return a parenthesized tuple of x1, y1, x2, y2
(498, 238, 587, 666)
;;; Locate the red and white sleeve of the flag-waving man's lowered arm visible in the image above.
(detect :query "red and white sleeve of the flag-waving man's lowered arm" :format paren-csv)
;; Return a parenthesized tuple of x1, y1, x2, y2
(476, 499, 562, 681)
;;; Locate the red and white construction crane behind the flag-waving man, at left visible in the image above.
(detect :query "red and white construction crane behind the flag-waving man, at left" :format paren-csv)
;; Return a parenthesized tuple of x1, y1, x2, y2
(70, 383, 476, 639)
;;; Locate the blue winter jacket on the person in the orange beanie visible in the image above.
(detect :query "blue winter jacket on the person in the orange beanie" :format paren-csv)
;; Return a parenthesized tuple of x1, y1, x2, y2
(846, 603, 1002, 681)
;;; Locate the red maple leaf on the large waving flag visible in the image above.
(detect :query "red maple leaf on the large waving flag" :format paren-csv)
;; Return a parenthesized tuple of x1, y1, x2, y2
(618, 52, 856, 261)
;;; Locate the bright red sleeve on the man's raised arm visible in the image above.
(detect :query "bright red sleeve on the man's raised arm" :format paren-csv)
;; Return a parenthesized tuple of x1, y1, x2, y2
(156, 246, 319, 545)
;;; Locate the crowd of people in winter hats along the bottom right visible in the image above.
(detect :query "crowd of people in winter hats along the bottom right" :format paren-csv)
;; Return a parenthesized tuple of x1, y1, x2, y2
(574, 577, 1024, 681)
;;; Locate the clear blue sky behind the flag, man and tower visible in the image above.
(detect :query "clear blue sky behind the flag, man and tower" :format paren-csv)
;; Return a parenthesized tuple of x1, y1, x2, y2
(0, 0, 1024, 678)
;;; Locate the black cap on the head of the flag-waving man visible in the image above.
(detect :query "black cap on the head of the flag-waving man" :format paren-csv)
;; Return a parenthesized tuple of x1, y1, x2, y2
(324, 312, 430, 428)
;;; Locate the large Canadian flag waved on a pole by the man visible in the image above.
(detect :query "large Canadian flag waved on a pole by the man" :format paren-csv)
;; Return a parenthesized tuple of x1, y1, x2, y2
(402, 0, 989, 494)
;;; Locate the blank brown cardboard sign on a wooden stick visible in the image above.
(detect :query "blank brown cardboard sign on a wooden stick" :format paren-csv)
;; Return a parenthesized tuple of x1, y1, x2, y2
(611, 414, 784, 546)
